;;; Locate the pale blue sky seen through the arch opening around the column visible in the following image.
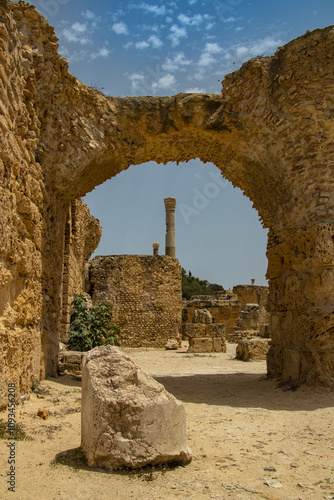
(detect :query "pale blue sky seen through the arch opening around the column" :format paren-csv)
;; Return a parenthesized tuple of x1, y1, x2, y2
(83, 159, 267, 288)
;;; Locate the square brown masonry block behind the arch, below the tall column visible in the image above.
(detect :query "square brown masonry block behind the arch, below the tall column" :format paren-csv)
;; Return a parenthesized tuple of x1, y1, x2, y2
(89, 255, 182, 347)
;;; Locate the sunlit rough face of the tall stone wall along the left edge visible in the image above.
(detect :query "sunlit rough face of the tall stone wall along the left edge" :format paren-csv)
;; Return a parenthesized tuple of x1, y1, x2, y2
(0, 2, 53, 406)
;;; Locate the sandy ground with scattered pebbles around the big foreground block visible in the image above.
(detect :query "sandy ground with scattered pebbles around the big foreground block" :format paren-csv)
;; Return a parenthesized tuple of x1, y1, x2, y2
(0, 346, 334, 500)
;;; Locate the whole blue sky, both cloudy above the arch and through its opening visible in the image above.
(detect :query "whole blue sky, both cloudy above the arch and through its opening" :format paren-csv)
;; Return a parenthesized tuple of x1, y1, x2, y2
(32, 0, 334, 288)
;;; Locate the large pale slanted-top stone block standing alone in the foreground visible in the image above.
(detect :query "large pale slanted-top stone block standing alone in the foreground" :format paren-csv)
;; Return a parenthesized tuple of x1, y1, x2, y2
(81, 346, 191, 469)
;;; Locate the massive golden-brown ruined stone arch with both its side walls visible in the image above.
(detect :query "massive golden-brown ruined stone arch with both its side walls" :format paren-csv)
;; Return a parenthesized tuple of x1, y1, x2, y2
(0, 0, 334, 402)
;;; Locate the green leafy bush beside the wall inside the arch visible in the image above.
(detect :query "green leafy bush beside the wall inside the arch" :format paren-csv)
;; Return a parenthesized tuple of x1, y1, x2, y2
(69, 295, 122, 352)
